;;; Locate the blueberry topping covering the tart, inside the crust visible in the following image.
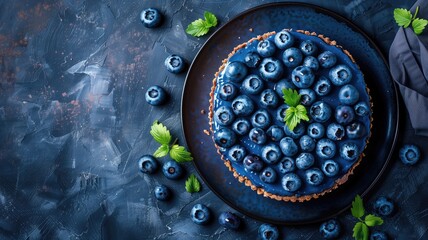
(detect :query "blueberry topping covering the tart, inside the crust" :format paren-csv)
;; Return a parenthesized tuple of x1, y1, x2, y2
(213, 30, 370, 193)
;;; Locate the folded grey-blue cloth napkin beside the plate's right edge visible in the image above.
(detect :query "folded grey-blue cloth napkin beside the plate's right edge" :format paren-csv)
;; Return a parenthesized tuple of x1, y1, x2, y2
(389, 0, 428, 136)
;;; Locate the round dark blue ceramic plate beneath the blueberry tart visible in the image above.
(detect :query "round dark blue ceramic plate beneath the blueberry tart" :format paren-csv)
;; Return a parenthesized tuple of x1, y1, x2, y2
(181, 3, 398, 224)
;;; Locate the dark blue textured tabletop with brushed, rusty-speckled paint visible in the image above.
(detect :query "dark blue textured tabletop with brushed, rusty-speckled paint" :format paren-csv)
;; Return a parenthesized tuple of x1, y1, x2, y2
(0, 0, 428, 239)
